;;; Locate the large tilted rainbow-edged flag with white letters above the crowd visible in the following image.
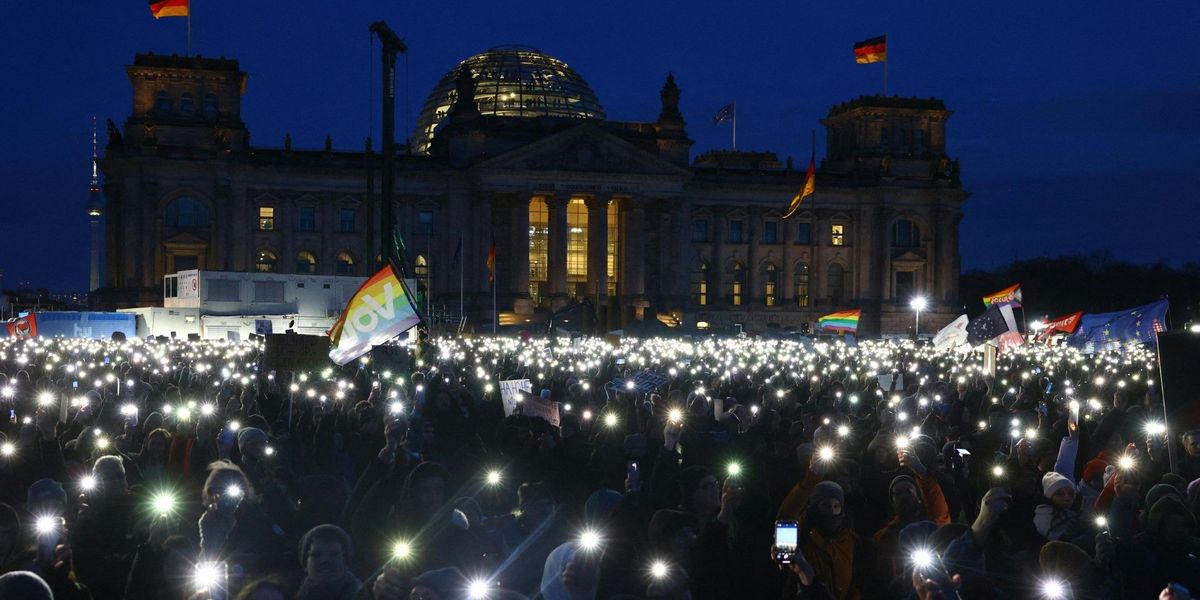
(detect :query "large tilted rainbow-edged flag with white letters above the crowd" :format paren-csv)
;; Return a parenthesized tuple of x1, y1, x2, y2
(325, 264, 421, 365)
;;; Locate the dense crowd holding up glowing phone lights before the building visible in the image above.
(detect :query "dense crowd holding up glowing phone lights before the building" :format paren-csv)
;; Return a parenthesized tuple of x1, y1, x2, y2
(0, 336, 1200, 600)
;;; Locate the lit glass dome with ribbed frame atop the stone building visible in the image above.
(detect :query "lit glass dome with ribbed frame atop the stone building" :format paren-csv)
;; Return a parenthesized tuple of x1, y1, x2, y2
(413, 46, 605, 152)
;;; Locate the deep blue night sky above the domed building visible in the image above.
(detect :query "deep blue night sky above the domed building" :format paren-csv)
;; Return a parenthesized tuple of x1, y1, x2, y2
(0, 0, 1200, 290)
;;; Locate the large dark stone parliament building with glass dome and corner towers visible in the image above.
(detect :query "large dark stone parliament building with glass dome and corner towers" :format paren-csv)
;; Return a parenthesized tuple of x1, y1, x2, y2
(100, 47, 967, 335)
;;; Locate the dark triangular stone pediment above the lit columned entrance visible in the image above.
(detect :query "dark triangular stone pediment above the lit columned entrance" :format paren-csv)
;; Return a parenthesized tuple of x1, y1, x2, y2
(475, 125, 691, 178)
